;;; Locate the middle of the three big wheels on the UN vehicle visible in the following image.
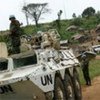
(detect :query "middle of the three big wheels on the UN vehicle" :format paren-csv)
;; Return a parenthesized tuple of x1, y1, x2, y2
(64, 74, 75, 100)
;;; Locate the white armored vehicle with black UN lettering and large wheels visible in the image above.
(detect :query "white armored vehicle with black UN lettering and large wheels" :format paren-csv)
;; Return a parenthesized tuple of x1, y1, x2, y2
(0, 29, 82, 100)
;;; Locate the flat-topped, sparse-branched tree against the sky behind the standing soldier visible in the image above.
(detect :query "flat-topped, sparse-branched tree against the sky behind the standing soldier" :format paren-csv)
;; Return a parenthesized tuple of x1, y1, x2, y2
(22, 3, 50, 27)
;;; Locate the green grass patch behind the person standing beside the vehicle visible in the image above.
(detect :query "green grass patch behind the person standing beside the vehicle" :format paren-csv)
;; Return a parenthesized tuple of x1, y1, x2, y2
(80, 59, 100, 84)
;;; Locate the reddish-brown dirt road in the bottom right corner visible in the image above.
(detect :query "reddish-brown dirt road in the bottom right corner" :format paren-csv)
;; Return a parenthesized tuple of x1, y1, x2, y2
(82, 76, 100, 100)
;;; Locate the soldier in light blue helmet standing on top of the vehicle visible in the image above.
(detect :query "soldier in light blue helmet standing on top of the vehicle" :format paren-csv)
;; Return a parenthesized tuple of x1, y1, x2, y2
(9, 15, 22, 54)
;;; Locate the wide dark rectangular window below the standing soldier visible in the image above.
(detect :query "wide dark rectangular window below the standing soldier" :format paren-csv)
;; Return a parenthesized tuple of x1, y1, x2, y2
(13, 55, 37, 68)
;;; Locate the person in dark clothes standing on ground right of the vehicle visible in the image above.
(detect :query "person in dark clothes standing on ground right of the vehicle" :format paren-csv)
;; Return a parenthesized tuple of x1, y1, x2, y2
(82, 53, 91, 85)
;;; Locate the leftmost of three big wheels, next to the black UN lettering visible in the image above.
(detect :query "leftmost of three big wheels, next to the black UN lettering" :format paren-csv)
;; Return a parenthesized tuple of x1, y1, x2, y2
(54, 77, 66, 100)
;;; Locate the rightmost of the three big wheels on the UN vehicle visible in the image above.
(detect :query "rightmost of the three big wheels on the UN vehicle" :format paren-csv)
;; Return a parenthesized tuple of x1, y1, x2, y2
(73, 72, 82, 100)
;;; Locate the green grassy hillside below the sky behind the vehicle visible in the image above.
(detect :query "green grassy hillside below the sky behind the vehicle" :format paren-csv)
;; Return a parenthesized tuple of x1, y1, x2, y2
(0, 15, 100, 48)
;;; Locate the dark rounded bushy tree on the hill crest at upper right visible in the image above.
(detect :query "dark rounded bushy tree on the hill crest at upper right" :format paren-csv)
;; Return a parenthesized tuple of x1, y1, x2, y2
(82, 7, 95, 17)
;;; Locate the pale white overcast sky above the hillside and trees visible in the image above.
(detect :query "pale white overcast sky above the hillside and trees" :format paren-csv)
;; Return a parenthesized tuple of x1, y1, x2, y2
(0, 0, 100, 30)
